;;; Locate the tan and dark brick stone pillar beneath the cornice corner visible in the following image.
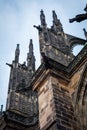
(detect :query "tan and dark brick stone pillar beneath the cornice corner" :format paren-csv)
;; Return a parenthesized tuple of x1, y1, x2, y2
(34, 69, 80, 130)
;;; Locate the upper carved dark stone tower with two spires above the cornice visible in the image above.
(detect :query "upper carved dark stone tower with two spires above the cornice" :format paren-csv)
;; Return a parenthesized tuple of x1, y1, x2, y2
(34, 10, 86, 66)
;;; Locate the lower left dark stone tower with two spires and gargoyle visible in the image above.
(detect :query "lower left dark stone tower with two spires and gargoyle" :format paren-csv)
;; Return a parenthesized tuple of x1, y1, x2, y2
(0, 40, 38, 130)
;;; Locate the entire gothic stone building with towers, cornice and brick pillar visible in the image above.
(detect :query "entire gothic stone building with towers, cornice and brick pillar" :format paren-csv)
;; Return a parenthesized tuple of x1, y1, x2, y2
(0, 10, 87, 130)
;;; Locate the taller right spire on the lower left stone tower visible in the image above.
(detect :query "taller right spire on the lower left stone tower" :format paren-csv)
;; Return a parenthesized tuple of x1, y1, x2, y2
(27, 39, 35, 72)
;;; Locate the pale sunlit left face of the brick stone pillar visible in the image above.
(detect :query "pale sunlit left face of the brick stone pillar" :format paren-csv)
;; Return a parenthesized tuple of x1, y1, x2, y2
(38, 79, 54, 129)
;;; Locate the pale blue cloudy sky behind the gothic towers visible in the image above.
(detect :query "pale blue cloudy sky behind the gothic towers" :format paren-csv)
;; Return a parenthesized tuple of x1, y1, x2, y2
(0, 0, 87, 110)
